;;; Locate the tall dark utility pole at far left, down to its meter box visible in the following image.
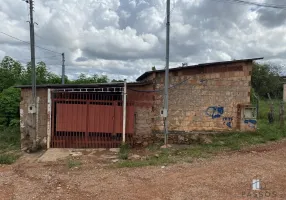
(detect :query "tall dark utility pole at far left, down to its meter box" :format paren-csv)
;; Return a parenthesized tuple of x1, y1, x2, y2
(26, 0, 36, 103)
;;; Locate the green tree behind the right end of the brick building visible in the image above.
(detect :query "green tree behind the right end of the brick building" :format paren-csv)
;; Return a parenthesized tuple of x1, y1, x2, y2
(251, 64, 283, 98)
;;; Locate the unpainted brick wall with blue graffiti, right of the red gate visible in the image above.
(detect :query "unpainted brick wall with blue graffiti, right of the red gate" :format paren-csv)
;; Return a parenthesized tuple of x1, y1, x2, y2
(152, 63, 252, 133)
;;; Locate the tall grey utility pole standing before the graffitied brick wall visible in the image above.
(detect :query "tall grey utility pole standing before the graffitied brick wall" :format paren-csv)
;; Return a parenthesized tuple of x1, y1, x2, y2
(163, 0, 170, 148)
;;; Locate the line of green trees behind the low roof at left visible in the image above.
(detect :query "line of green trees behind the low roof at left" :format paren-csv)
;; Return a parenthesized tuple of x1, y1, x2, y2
(0, 56, 123, 128)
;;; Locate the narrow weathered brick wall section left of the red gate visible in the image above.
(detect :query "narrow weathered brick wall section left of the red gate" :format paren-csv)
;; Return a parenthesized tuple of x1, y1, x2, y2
(20, 88, 47, 151)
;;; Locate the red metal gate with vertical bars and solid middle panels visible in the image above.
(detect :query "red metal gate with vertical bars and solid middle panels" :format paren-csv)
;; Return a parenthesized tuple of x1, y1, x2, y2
(51, 92, 135, 148)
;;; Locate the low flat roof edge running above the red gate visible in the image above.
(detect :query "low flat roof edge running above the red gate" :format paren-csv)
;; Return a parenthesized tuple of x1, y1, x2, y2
(15, 81, 152, 88)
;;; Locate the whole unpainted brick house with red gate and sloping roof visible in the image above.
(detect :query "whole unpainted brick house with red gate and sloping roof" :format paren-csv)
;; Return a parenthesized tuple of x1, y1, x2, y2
(15, 58, 262, 150)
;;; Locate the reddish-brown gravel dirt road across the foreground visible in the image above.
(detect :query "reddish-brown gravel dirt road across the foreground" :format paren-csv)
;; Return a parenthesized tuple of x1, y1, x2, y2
(0, 141, 286, 200)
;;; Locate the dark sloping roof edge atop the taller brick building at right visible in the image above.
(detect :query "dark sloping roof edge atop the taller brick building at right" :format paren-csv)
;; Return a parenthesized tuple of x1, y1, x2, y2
(136, 57, 263, 81)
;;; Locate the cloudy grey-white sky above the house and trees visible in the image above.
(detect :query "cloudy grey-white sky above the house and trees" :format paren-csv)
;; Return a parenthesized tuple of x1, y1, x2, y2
(0, 0, 286, 81)
